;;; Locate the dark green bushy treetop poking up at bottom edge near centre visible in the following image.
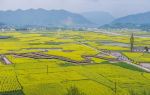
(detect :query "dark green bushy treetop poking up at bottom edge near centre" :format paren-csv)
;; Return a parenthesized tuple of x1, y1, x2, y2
(65, 86, 86, 95)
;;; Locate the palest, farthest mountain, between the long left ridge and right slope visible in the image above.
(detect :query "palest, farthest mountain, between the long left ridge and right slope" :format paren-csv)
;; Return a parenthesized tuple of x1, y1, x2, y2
(81, 11, 115, 26)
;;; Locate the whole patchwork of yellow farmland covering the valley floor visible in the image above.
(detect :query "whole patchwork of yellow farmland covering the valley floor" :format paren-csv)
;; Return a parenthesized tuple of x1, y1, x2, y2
(0, 30, 150, 95)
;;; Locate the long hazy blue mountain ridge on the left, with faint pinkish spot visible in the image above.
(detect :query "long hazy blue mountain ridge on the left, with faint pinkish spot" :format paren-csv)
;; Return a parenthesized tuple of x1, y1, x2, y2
(0, 9, 91, 27)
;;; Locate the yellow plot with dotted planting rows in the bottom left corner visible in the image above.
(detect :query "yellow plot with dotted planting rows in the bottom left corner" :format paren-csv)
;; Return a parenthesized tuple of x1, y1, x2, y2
(0, 65, 24, 95)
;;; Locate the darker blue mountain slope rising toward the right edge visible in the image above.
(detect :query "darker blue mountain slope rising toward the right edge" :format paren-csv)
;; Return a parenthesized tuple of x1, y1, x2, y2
(102, 12, 150, 31)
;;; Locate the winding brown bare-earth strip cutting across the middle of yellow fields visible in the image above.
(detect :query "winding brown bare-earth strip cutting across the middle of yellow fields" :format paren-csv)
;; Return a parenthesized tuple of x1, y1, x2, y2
(9, 52, 117, 64)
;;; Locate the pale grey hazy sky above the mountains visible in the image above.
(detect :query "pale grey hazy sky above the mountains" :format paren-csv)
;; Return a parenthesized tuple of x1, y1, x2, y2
(0, 0, 150, 17)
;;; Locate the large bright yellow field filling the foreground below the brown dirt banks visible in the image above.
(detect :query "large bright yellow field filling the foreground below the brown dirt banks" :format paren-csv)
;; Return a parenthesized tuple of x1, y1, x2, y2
(2, 58, 150, 95)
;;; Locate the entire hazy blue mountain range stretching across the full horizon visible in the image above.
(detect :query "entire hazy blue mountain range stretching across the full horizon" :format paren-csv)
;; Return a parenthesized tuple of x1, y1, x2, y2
(0, 9, 150, 29)
